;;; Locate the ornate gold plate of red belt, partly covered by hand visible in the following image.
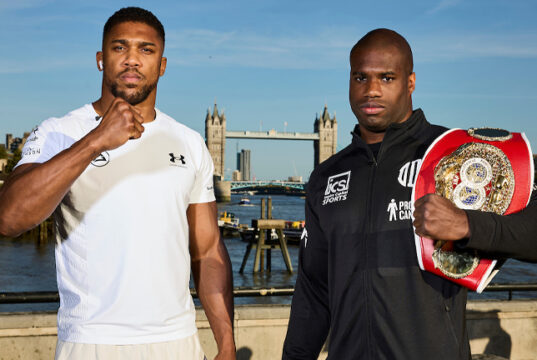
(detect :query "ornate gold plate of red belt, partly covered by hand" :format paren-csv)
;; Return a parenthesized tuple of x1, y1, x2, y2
(433, 141, 515, 279)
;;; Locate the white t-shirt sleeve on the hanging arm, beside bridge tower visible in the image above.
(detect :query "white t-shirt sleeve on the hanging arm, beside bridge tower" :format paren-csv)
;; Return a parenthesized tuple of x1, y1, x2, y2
(190, 135, 215, 204)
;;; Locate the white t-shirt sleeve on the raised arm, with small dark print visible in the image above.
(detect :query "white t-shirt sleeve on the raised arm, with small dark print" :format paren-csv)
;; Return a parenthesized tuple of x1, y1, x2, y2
(16, 119, 66, 166)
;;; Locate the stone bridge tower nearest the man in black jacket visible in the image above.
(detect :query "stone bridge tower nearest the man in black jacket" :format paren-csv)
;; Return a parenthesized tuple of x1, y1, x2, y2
(313, 105, 337, 166)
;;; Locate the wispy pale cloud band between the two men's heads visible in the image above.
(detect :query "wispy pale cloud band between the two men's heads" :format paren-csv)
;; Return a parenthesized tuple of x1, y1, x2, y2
(166, 29, 356, 69)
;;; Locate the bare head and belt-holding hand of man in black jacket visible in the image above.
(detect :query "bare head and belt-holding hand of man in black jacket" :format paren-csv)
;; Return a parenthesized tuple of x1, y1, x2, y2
(349, 29, 471, 241)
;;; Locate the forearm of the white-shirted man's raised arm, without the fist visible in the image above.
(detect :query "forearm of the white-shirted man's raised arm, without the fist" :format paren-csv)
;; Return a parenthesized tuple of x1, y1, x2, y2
(0, 132, 99, 236)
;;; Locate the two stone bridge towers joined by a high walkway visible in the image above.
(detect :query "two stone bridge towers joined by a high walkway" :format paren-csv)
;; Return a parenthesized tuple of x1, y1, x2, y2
(205, 103, 337, 180)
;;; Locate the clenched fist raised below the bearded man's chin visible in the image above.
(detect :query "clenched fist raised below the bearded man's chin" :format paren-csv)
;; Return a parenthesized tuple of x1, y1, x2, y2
(88, 98, 144, 152)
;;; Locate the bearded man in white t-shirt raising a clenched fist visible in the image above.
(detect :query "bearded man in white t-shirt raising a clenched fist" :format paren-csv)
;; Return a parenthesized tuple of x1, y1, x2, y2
(0, 7, 235, 360)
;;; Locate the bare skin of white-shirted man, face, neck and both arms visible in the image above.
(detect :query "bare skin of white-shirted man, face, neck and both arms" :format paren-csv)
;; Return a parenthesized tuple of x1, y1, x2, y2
(0, 22, 235, 360)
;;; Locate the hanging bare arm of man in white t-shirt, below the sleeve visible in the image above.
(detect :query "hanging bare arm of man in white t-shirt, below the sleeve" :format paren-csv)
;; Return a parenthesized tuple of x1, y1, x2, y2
(187, 201, 235, 360)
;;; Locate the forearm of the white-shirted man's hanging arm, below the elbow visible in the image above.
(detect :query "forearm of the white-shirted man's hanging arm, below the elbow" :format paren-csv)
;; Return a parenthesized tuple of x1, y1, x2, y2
(192, 241, 235, 353)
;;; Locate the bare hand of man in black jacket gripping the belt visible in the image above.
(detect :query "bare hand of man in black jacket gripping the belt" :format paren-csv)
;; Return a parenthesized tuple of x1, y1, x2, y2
(413, 194, 470, 241)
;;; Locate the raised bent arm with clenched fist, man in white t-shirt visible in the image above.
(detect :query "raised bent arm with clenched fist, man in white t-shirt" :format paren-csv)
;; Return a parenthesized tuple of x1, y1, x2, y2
(0, 99, 144, 237)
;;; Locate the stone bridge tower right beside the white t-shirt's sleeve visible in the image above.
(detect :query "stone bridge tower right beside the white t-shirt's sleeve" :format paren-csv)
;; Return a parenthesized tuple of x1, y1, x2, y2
(205, 102, 226, 180)
